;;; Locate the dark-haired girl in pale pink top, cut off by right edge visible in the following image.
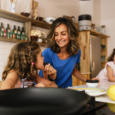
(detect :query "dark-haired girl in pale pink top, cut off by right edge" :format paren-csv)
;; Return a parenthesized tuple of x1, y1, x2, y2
(93, 48, 115, 89)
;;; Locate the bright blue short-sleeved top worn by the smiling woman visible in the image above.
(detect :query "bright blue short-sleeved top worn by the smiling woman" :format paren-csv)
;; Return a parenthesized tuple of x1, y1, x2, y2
(39, 48, 81, 88)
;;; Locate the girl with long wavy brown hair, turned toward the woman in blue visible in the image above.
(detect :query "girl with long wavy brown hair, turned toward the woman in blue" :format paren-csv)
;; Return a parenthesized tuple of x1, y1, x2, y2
(1, 42, 57, 89)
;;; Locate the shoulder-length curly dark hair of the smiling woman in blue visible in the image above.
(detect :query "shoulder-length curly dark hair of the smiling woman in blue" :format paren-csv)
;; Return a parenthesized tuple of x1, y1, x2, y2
(47, 17, 79, 55)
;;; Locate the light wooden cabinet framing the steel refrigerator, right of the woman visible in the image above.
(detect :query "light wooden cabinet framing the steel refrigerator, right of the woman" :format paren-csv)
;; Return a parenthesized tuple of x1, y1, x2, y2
(73, 30, 109, 85)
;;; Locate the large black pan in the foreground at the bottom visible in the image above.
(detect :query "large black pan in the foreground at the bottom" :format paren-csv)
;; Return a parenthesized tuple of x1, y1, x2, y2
(0, 88, 90, 115)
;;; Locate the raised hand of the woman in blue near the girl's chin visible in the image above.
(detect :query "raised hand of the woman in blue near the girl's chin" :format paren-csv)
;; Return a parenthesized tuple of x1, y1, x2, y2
(44, 64, 56, 80)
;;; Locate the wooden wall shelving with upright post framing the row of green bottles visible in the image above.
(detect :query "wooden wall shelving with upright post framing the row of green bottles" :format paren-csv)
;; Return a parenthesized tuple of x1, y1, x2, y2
(0, 9, 50, 42)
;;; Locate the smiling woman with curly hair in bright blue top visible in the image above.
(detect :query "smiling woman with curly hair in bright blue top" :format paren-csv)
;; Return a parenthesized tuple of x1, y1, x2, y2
(40, 17, 86, 88)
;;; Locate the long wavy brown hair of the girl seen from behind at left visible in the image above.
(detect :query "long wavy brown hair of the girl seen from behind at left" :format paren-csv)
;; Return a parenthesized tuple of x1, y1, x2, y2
(2, 42, 41, 80)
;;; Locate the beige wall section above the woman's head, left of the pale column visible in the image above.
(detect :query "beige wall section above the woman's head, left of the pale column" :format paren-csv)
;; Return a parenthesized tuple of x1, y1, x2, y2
(36, 0, 79, 17)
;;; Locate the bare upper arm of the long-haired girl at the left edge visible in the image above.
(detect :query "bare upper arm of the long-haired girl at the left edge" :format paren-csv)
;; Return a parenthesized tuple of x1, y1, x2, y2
(0, 70, 19, 90)
